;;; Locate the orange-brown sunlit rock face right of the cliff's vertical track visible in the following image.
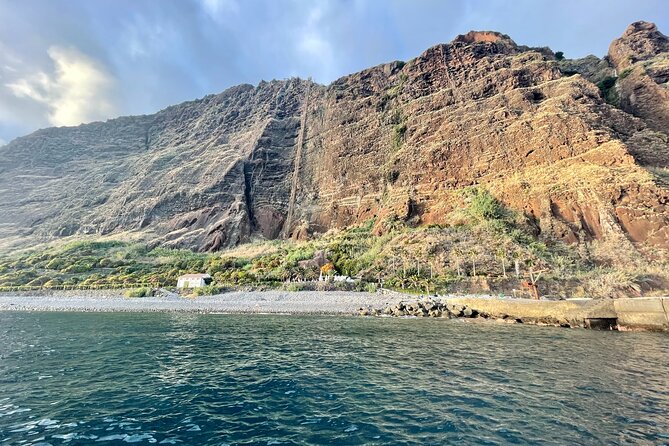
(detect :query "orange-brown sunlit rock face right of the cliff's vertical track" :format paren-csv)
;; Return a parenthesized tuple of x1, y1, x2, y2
(292, 28, 669, 251)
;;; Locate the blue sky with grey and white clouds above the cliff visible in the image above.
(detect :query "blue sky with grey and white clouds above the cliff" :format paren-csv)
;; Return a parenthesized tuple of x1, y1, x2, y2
(0, 0, 669, 145)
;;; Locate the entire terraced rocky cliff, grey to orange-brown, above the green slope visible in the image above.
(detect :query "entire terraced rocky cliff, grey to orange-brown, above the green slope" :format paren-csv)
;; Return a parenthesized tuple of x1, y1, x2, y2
(0, 24, 669, 250)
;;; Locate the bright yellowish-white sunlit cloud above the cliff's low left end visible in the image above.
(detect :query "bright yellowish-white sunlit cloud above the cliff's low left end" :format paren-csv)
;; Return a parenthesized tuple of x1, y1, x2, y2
(5, 46, 117, 126)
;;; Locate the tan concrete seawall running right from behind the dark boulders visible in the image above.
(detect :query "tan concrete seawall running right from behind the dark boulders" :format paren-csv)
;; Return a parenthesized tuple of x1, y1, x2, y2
(446, 297, 669, 331)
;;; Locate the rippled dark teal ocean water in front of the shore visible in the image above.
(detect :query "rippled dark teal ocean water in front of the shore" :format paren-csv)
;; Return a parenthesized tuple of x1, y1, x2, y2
(0, 313, 669, 445)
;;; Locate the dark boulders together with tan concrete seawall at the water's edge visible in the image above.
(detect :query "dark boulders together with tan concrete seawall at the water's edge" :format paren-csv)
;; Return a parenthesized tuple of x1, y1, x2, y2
(357, 297, 669, 331)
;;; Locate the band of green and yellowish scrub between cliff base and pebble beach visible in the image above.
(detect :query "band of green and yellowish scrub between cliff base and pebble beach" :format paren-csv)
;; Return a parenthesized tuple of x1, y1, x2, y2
(0, 187, 669, 297)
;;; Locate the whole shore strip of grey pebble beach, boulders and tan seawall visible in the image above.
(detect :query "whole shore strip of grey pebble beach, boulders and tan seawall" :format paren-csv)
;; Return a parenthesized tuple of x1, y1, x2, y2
(0, 290, 669, 332)
